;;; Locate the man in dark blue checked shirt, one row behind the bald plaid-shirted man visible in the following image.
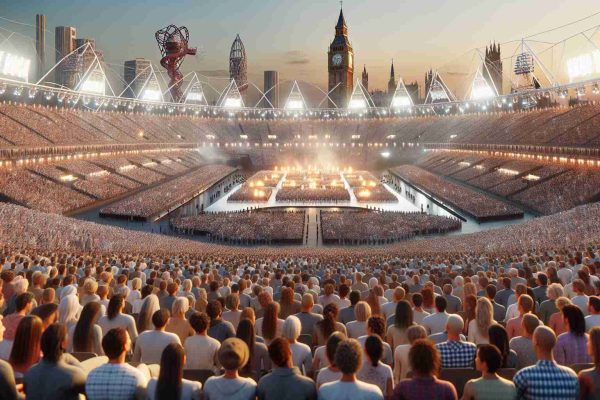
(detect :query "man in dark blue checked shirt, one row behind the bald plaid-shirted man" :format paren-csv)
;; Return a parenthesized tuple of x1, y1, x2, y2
(435, 315, 477, 368)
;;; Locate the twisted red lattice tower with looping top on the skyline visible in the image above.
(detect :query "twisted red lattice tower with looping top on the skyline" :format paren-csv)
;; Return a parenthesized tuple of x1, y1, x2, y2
(154, 25, 196, 103)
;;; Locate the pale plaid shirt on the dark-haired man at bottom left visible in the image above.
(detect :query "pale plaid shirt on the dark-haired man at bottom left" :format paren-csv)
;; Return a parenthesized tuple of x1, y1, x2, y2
(85, 364, 147, 400)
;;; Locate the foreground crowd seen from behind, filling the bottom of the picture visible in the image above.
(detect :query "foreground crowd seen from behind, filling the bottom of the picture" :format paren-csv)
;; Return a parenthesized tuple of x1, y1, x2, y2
(0, 227, 600, 400)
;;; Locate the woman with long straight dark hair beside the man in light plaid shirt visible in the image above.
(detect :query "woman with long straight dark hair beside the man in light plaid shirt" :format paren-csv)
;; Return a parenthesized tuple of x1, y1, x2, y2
(146, 343, 202, 400)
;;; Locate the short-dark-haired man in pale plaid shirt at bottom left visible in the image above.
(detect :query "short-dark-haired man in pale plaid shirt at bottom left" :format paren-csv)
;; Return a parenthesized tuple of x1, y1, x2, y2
(85, 328, 147, 400)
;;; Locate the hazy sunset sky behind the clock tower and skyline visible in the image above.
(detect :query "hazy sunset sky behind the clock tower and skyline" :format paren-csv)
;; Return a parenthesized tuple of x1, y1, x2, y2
(0, 0, 593, 94)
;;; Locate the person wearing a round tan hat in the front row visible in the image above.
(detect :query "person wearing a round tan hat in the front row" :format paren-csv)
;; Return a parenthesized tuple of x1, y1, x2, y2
(204, 338, 256, 400)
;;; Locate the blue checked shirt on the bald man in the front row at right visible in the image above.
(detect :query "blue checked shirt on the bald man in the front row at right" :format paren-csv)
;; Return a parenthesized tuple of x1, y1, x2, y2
(513, 360, 579, 400)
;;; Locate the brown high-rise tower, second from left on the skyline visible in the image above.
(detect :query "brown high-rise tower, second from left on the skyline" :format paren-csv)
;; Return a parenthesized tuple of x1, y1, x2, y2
(54, 26, 81, 88)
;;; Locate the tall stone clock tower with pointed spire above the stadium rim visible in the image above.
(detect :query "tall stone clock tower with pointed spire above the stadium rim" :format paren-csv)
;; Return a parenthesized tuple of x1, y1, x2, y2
(327, 8, 354, 108)
